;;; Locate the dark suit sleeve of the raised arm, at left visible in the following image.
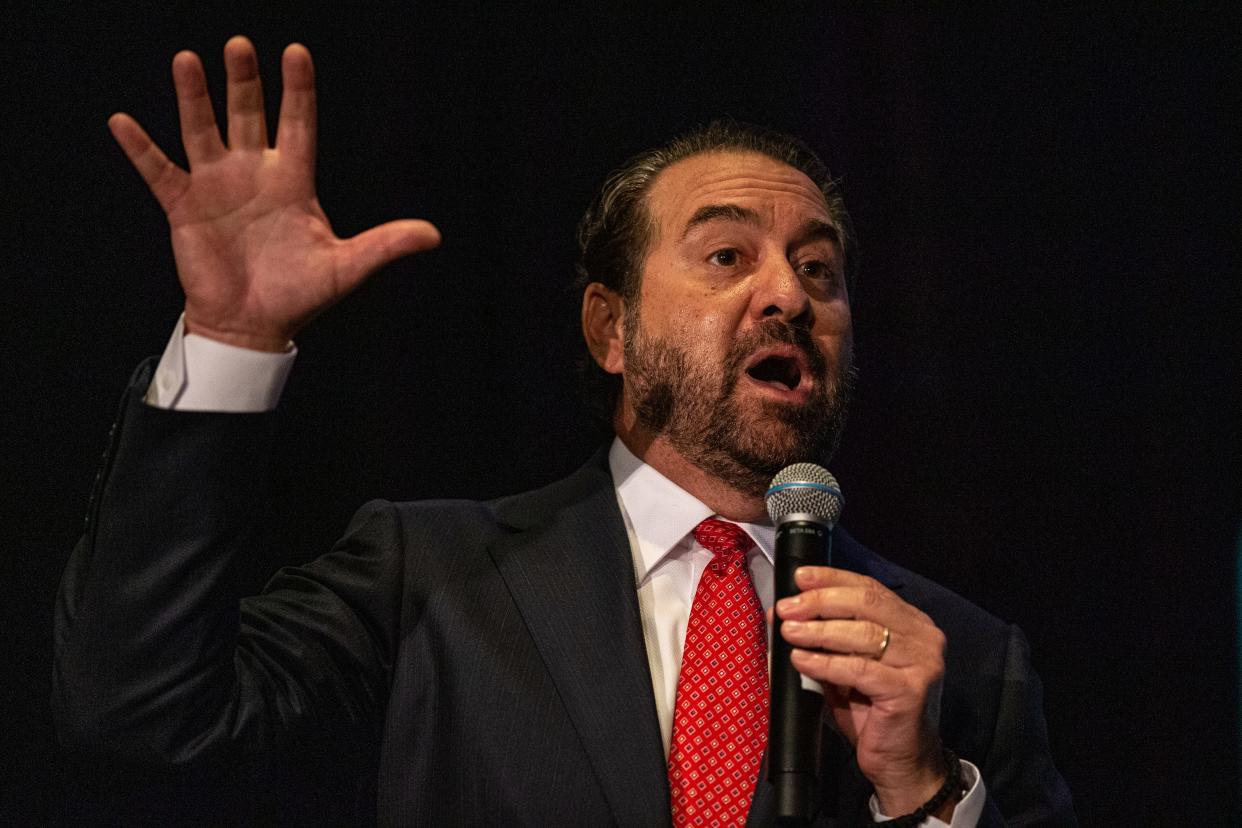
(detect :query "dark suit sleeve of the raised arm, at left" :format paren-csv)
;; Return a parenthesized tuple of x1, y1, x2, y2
(52, 362, 402, 763)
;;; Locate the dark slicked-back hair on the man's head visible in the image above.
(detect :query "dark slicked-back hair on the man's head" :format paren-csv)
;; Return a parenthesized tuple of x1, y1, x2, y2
(575, 120, 858, 425)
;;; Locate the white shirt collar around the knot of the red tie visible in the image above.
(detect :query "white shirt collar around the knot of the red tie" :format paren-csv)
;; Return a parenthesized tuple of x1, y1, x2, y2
(609, 438, 776, 583)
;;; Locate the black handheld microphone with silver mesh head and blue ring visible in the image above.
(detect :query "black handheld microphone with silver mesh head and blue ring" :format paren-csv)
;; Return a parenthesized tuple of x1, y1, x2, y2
(764, 463, 845, 826)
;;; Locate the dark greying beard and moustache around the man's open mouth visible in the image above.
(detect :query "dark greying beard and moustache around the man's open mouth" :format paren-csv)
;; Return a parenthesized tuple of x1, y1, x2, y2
(625, 307, 857, 497)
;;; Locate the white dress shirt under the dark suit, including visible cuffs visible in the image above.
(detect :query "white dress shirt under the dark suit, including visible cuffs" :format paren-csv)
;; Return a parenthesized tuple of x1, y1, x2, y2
(145, 319, 986, 828)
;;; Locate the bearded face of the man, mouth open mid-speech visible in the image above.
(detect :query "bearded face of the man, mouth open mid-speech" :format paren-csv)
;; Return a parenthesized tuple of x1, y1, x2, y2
(623, 151, 853, 493)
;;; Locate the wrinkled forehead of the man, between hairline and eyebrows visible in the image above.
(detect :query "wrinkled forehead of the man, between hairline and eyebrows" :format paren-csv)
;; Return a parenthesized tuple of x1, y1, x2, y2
(647, 150, 840, 237)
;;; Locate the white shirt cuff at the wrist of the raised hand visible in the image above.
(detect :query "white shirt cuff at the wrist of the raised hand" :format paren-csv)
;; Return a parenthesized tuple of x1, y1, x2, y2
(145, 314, 298, 413)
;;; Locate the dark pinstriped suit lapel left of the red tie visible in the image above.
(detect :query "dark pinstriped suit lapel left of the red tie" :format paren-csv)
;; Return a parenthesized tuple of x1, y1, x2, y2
(491, 454, 669, 826)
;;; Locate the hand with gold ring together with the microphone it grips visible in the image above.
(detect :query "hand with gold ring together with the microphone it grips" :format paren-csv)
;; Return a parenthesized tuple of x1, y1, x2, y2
(768, 463, 953, 824)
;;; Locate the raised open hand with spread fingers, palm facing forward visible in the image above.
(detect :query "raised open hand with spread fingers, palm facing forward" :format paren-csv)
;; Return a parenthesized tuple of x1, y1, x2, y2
(108, 36, 440, 351)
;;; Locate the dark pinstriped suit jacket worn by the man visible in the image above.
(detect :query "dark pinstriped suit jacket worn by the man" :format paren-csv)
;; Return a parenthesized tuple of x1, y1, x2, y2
(55, 366, 1073, 826)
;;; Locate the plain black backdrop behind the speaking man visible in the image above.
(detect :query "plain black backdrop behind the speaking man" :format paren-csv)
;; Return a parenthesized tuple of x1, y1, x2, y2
(0, 1, 1242, 824)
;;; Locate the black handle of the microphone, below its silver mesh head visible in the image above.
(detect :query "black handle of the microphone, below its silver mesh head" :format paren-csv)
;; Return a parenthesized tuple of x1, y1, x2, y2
(768, 515, 835, 826)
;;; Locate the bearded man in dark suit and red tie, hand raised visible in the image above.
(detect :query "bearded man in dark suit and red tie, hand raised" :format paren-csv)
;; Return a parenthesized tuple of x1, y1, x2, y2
(56, 37, 1073, 826)
